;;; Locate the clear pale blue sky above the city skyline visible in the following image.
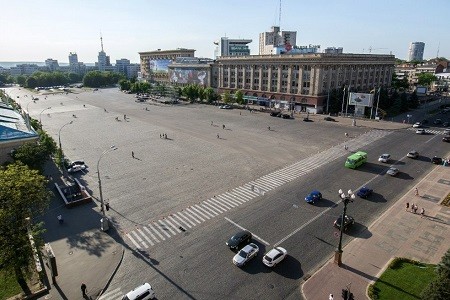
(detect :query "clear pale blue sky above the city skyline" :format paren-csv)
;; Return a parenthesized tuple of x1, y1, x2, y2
(0, 0, 450, 63)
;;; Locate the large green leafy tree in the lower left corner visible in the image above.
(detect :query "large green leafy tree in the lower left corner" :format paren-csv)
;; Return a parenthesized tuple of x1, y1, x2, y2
(0, 163, 50, 285)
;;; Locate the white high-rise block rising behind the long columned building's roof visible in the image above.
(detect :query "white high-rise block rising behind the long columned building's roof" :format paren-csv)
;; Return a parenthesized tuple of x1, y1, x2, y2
(259, 26, 297, 55)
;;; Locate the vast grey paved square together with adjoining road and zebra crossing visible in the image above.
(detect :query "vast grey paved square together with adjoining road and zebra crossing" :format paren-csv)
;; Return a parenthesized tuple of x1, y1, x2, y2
(6, 85, 448, 299)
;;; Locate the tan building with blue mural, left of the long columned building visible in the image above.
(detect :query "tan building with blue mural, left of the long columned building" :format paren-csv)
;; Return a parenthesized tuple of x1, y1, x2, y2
(139, 48, 195, 83)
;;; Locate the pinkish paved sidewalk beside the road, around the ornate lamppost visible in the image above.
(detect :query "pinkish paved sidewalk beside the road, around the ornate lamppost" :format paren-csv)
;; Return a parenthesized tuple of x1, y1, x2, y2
(302, 166, 450, 300)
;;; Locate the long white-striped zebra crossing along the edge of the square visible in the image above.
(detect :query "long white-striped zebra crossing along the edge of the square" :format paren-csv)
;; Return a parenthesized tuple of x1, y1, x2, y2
(125, 130, 391, 250)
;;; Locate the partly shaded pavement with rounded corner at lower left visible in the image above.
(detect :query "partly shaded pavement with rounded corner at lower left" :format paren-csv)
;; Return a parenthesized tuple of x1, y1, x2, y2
(39, 166, 124, 300)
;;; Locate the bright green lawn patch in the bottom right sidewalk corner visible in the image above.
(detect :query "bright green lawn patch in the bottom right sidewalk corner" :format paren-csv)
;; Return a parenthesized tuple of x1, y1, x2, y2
(369, 258, 436, 300)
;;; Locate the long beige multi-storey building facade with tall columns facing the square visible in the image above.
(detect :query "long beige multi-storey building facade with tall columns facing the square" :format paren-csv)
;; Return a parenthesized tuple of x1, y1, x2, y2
(216, 53, 395, 113)
